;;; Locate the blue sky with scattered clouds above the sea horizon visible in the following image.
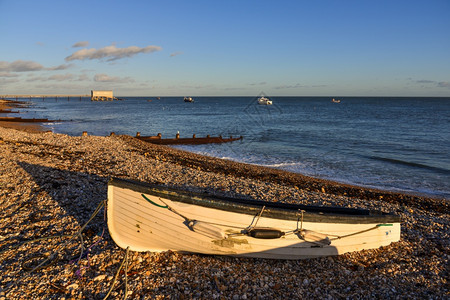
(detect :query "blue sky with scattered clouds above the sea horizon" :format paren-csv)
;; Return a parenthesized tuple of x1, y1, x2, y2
(0, 0, 450, 97)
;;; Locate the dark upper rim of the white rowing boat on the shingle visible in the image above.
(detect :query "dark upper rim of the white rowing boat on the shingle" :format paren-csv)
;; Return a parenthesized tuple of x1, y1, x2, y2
(108, 178, 400, 224)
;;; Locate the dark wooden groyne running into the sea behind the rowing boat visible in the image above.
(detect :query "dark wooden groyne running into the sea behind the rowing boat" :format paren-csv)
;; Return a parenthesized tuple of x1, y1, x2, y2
(136, 132, 243, 145)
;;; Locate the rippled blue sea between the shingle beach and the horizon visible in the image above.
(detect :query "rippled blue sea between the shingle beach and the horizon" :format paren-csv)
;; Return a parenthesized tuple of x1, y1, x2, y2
(11, 97, 450, 199)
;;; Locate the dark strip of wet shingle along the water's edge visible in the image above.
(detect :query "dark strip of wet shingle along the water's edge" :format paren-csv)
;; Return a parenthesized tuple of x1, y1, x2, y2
(119, 135, 449, 207)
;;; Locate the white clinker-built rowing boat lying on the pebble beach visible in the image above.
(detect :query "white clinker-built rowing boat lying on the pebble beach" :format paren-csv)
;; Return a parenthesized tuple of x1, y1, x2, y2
(107, 179, 400, 259)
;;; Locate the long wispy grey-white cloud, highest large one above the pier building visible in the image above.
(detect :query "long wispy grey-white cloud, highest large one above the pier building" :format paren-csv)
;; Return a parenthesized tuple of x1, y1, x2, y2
(66, 45, 162, 61)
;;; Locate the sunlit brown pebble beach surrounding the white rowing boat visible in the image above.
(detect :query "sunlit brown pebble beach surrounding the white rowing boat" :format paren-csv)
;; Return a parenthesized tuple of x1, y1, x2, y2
(0, 100, 450, 300)
